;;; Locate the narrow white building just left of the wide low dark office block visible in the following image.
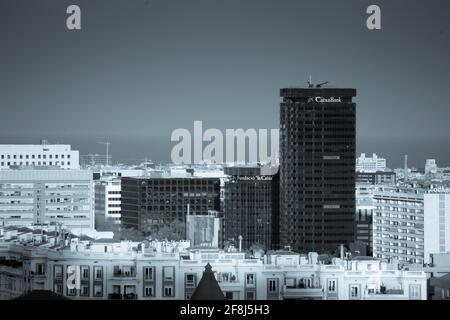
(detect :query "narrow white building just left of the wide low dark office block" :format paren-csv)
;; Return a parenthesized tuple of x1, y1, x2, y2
(95, 177, 122, 224)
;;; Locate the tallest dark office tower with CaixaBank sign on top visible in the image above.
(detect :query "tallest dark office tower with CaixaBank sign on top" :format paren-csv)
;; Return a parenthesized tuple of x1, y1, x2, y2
(280, 85, 356, 252)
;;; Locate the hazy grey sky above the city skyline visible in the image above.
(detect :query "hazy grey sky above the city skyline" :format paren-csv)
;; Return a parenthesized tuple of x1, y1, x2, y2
(0, 0, 450, 165)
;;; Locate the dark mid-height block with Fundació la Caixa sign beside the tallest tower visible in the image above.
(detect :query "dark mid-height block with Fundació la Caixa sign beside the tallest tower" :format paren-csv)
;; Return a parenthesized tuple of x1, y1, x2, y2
(224, 167, 279, 249)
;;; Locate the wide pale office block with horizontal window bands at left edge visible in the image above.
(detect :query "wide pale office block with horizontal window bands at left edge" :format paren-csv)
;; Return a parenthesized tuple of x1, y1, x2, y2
(0, 169, 94, 229)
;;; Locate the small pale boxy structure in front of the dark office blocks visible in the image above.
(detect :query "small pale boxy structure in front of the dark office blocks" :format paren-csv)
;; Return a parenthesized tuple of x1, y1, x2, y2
(186, 211, 222, 248)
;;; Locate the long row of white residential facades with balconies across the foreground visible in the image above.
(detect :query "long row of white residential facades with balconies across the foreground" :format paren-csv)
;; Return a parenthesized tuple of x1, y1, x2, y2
(0, 228, 427, 300)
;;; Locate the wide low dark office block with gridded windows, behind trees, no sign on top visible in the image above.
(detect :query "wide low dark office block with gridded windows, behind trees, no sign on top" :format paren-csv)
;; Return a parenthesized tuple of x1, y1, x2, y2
(121, 177, 220, 239)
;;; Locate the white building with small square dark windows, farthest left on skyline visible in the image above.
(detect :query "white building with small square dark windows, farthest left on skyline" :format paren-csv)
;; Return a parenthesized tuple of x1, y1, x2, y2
(0, 141, 80, 170)
